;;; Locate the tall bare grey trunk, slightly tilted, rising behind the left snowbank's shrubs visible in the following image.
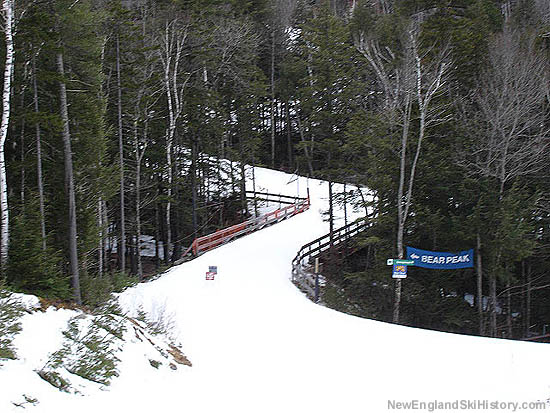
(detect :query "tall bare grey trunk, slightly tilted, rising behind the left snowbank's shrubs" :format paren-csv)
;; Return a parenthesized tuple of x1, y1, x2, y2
(57, 52, 82, 304)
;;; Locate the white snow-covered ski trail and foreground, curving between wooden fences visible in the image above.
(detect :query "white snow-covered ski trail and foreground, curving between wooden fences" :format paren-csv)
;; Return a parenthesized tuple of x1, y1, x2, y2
(0, 169, 550, 413)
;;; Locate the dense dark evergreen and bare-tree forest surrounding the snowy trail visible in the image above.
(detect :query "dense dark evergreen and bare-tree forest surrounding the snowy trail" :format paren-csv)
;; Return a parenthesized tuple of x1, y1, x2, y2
(0, 0, 550, 338)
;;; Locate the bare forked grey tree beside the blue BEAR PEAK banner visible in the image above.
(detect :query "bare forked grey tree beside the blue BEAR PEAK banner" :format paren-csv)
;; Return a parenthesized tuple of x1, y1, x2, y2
(355, 21, 450, 323)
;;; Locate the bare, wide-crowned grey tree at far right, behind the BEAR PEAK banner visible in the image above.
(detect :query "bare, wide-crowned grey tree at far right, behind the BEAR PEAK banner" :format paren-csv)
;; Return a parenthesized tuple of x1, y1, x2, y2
(467, 28, 550, 335)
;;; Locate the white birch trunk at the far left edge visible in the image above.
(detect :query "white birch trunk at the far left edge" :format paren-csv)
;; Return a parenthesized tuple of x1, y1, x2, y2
(0, 0, 15, 276)
